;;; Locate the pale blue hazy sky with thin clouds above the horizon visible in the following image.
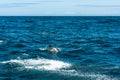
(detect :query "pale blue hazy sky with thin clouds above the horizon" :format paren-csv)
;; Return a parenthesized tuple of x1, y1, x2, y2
(0, 0, 120, 16)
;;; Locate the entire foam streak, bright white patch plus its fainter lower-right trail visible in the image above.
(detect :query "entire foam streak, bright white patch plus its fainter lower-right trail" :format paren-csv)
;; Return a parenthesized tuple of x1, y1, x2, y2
(0, 58, 118, 80)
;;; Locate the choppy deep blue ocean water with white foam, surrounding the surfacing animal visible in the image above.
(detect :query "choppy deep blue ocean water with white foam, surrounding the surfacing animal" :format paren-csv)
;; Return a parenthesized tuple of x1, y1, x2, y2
(0, 16, 120, 80)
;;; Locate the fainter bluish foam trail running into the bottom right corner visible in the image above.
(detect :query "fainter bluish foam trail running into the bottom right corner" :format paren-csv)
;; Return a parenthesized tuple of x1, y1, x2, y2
(57, 70, 119, 80)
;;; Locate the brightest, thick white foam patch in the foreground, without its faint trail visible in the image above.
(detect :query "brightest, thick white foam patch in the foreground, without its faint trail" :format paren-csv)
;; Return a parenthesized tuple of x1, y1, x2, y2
(1, 58, 71, 70)
